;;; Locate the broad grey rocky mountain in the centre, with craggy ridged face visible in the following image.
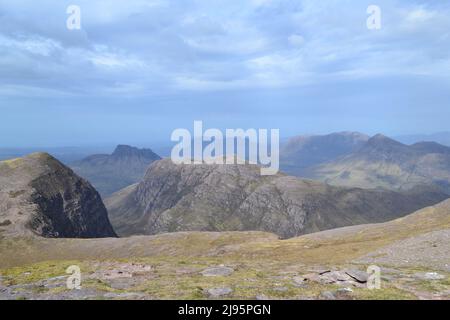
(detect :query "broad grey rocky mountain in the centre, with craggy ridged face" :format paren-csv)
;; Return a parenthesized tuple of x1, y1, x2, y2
(106, 159, 446, 238)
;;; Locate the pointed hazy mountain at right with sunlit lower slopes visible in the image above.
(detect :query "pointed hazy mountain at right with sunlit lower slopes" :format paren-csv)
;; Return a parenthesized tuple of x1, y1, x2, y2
(310, 135, 450, 194)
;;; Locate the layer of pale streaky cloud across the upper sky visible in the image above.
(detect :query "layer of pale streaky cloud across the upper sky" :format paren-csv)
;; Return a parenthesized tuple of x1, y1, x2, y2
(0, 0, 450, 96)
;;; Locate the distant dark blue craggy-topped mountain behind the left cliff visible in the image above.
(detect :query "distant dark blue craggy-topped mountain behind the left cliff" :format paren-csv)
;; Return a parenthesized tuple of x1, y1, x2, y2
(70, 145, 161, 196)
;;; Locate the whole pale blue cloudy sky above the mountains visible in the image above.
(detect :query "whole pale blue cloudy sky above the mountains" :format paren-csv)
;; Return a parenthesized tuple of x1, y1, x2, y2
(0, 0, 450, 147)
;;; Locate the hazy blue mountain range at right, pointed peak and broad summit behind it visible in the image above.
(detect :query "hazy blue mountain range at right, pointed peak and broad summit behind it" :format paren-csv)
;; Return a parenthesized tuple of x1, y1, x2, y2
(281, 133, 450, 194)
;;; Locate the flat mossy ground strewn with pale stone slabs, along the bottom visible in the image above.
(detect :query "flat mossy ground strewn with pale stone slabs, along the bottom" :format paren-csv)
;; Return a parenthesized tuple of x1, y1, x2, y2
(0, 259, 450, 300)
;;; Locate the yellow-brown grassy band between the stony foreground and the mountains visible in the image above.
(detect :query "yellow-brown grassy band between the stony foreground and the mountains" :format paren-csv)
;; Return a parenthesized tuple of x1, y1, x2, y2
(0, 201, 450, 267)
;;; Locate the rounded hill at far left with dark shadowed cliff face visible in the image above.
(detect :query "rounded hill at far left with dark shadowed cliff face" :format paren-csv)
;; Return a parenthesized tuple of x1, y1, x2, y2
(0, 153, 116, 238)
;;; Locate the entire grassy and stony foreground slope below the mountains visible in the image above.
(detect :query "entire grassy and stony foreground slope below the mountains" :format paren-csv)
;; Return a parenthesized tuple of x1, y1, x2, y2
(0, 201, 450, 299)
